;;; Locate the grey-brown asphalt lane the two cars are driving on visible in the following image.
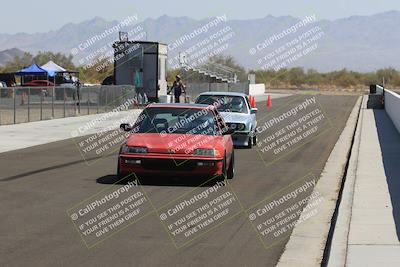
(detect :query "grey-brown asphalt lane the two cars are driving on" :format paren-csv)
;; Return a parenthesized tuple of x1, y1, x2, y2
(0, 95, 357, 266)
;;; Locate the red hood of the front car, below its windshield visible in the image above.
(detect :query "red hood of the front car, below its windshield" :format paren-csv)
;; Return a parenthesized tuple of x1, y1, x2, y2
(126, 133, 224, 154)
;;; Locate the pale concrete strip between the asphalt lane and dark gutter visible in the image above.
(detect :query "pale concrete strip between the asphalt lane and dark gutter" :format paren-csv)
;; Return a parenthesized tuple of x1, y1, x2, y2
(277, 97, 361, 267)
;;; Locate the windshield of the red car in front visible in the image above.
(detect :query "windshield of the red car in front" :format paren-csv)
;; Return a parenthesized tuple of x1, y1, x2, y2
(133, 108, 220, 135)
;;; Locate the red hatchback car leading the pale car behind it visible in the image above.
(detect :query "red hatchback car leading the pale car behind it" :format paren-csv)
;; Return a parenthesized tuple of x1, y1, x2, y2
(118, 104, 234, 179)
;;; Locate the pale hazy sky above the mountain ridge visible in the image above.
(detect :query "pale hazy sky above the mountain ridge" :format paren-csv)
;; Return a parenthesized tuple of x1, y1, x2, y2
(0, 0, 400, 33)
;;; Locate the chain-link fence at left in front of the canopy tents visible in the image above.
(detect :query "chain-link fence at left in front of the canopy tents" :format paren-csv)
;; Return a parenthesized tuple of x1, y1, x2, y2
(0, 86, 136, 125)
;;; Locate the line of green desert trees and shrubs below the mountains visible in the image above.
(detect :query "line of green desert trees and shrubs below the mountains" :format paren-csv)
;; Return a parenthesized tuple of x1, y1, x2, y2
(0, 52, 400, 88)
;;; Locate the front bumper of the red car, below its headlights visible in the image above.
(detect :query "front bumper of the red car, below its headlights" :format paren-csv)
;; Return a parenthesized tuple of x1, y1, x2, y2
(119, 154, 224, 177)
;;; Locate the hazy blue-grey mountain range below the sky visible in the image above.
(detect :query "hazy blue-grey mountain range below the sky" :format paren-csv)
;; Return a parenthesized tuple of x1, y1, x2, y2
(0, 11, 400, 72)
